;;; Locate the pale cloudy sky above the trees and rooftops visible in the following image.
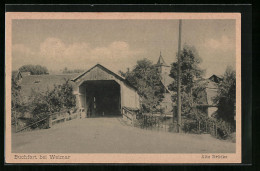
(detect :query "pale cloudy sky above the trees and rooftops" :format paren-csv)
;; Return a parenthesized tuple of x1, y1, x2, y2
(12, 19, 236, 77)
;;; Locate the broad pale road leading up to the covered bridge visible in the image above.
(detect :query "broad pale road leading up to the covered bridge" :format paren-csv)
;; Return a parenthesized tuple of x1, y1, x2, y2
(12, 118, 235, 153)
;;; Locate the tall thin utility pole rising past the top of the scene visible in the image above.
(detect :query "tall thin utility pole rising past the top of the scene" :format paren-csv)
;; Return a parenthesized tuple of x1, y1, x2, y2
(177, 20, 182, 133)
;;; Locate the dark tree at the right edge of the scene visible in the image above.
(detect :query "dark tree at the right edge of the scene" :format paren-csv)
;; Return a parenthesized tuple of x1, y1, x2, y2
(214, 66, 236, 125)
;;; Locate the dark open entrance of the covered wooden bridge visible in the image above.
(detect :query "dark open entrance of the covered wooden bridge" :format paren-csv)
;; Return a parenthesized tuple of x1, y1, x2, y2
(85, 80, 121, 117)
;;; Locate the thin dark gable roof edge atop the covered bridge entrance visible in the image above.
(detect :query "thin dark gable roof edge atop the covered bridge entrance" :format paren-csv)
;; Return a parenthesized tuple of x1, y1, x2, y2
(71, 64, 137, 90)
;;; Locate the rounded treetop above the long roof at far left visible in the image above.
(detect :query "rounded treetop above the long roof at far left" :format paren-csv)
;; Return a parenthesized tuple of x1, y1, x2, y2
(19, 65, 48, 75)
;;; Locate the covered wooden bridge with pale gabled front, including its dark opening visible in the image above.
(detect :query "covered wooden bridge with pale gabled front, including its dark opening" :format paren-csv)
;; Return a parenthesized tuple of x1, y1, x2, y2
(71, 64, 140, 117)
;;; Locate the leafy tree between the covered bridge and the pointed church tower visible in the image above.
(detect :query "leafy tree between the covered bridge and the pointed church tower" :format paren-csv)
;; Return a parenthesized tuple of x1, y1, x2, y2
(120, 59, 164, 112)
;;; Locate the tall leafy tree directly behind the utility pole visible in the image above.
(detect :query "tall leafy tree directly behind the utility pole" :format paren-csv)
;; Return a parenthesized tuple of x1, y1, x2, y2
(169, 45, 205, 115)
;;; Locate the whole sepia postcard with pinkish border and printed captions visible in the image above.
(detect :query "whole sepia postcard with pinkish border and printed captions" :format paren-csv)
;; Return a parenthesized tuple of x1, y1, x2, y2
(5, 13, 241, 163)
